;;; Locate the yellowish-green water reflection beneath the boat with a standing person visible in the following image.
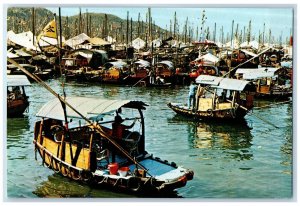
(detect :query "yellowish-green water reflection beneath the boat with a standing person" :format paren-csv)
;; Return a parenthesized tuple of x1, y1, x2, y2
(171, 115, 253, 160)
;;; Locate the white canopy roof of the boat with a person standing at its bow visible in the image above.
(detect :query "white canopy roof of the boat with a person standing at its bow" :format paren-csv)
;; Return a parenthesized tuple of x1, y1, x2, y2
(196, 75, 250, 91)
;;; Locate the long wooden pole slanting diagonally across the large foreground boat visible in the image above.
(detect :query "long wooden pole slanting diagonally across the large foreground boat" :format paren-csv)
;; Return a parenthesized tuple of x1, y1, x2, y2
(7, 58, 152, 176)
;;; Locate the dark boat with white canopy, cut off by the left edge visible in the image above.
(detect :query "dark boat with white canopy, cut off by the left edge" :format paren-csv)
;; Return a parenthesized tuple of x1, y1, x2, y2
(7, 75, 30, 117)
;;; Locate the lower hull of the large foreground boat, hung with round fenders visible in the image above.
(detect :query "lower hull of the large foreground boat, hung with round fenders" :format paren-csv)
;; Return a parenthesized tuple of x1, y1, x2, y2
(33, 138, 194, 194)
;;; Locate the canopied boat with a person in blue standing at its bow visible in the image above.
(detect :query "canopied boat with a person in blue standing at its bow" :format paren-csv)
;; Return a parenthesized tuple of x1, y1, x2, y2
(168, 75, 255, 120)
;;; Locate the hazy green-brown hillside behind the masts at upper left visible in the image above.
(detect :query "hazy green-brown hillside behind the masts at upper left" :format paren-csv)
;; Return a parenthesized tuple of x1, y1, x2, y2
(7, 7, 169, 42)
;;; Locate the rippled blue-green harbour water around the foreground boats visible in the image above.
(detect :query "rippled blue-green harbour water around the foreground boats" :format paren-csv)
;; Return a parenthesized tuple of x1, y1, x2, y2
(6, 80, 293, 198)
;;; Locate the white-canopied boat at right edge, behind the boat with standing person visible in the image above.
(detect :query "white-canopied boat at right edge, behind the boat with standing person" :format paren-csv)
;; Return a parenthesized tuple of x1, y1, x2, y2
(236, 67, 293, 99)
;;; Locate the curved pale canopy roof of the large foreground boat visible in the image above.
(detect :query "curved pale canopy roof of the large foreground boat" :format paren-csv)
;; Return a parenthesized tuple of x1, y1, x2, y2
(36, 97, 148, 120)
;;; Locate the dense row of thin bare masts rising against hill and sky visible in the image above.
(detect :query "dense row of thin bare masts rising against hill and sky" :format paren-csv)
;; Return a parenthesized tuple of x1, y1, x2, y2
(8, 8, 292, 46)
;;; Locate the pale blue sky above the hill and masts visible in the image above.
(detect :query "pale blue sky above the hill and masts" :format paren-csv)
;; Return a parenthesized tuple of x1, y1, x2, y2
(47, 5, 294, 41)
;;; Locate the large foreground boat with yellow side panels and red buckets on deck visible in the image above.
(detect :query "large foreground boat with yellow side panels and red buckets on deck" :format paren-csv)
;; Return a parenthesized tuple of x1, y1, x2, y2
(33, 97, 193, 193)
